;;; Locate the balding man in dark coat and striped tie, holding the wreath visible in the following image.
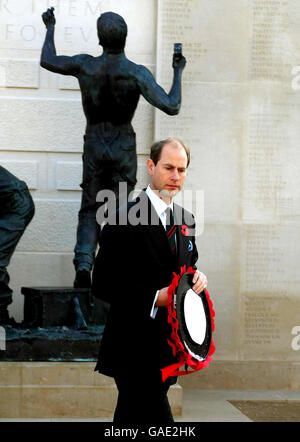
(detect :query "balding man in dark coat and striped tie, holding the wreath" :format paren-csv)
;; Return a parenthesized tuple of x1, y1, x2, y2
(92, 138, 207, 424)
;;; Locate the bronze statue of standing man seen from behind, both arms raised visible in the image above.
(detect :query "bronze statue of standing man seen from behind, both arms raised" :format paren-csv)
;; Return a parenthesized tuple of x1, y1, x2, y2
(41, 8, 186, 288)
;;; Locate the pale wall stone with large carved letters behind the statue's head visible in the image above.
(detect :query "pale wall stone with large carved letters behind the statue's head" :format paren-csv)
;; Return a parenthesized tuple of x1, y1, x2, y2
(0, 0, 155, 55)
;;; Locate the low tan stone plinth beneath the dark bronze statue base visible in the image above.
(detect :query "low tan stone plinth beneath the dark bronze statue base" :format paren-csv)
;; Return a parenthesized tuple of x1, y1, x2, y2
(0, 362, 182, 418)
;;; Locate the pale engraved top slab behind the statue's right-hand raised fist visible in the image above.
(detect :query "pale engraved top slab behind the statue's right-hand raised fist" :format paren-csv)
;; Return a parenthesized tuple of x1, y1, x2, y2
(157, 0, 249, 84)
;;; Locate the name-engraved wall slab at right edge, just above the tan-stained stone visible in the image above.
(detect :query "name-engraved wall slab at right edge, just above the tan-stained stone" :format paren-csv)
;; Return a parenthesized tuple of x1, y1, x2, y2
(241, 224, 300, 296)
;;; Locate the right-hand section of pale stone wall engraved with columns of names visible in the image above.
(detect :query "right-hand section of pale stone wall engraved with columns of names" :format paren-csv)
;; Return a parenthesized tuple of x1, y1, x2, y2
(155, 0, 300, 382)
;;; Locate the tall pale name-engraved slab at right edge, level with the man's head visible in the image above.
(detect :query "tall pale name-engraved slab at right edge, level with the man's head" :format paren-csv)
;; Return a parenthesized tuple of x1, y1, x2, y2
(242, 84, 300, 224)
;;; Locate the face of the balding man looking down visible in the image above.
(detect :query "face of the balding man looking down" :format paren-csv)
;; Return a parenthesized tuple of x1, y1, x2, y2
(147, 143, 187, 198)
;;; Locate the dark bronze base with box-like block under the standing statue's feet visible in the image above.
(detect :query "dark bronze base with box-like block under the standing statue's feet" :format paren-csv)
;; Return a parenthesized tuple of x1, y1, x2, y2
(0, 287, 109, 361)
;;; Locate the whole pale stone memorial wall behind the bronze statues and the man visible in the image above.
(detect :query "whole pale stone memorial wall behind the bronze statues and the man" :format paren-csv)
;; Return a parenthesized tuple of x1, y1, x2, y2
(0, 0, 300, 385)
